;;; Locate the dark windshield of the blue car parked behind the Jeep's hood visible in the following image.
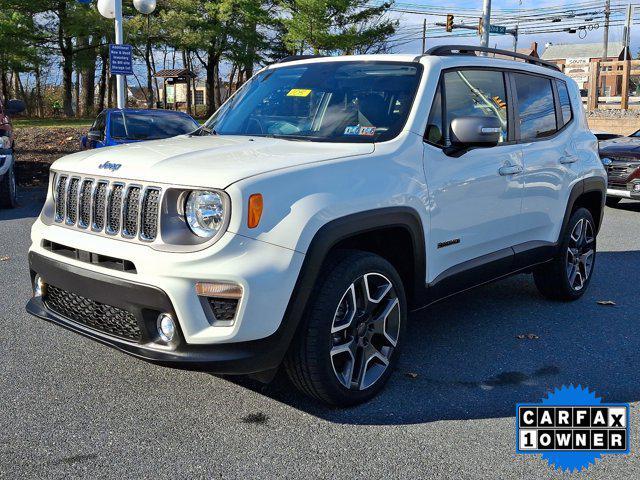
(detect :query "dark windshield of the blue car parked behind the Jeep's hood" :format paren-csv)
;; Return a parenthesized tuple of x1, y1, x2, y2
(110, 112, 198, 140)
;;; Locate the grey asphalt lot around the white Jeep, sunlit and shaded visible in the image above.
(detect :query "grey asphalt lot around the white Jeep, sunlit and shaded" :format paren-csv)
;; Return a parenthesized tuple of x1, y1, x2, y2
(0, 190, 640, 479)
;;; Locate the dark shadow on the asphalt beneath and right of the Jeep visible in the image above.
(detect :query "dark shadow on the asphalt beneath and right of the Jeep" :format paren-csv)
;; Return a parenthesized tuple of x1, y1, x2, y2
(234, 251, 640, 425)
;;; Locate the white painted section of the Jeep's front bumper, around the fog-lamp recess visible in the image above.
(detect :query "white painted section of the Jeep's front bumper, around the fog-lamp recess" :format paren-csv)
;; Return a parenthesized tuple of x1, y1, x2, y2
(30, 220, 304, 345)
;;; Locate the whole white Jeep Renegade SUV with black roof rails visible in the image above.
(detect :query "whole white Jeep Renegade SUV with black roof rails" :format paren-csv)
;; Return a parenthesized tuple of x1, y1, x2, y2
(27, 46, 606, 405)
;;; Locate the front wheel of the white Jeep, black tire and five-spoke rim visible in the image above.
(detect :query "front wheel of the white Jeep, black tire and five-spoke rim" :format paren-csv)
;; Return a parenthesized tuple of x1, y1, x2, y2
(285, 251, 407, 406)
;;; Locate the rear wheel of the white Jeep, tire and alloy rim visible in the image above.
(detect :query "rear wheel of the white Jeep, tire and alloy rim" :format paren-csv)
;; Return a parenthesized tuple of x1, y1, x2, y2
(533, 208, 596, 302)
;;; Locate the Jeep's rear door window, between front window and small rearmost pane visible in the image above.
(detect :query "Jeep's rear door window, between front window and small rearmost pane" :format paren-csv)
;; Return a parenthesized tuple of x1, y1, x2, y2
(513, 73, 557, 140)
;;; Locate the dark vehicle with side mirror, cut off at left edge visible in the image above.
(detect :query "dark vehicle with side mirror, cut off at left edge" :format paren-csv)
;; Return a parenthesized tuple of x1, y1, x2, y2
(0, 100, 25, 208)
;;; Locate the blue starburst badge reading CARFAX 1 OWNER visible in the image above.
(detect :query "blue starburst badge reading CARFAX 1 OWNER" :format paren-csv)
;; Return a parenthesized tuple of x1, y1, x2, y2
(516, 385, 629, 472)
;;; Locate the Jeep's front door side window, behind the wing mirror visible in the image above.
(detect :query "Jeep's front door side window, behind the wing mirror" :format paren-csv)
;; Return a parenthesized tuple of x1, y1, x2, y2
(425, 69, 509, 146)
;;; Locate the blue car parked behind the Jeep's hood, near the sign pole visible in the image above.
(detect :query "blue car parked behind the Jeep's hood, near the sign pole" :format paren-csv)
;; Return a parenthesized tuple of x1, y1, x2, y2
(80, 108, 200, 150)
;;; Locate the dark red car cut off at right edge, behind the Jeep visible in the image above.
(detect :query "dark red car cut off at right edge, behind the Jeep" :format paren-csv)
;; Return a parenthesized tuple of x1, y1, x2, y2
(600, 130, 640, 207)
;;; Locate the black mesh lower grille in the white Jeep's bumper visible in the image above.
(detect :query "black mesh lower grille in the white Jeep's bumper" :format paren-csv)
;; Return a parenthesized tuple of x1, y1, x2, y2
(45, 285, 142, 342)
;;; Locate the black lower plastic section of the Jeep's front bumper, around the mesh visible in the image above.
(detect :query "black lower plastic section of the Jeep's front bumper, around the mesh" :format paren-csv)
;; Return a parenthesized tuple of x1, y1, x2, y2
(26, 252, 292, 374)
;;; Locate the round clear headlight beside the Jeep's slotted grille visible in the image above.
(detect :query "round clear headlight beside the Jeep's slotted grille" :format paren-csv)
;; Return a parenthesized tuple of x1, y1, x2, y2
(185, 190, 225, 238)
